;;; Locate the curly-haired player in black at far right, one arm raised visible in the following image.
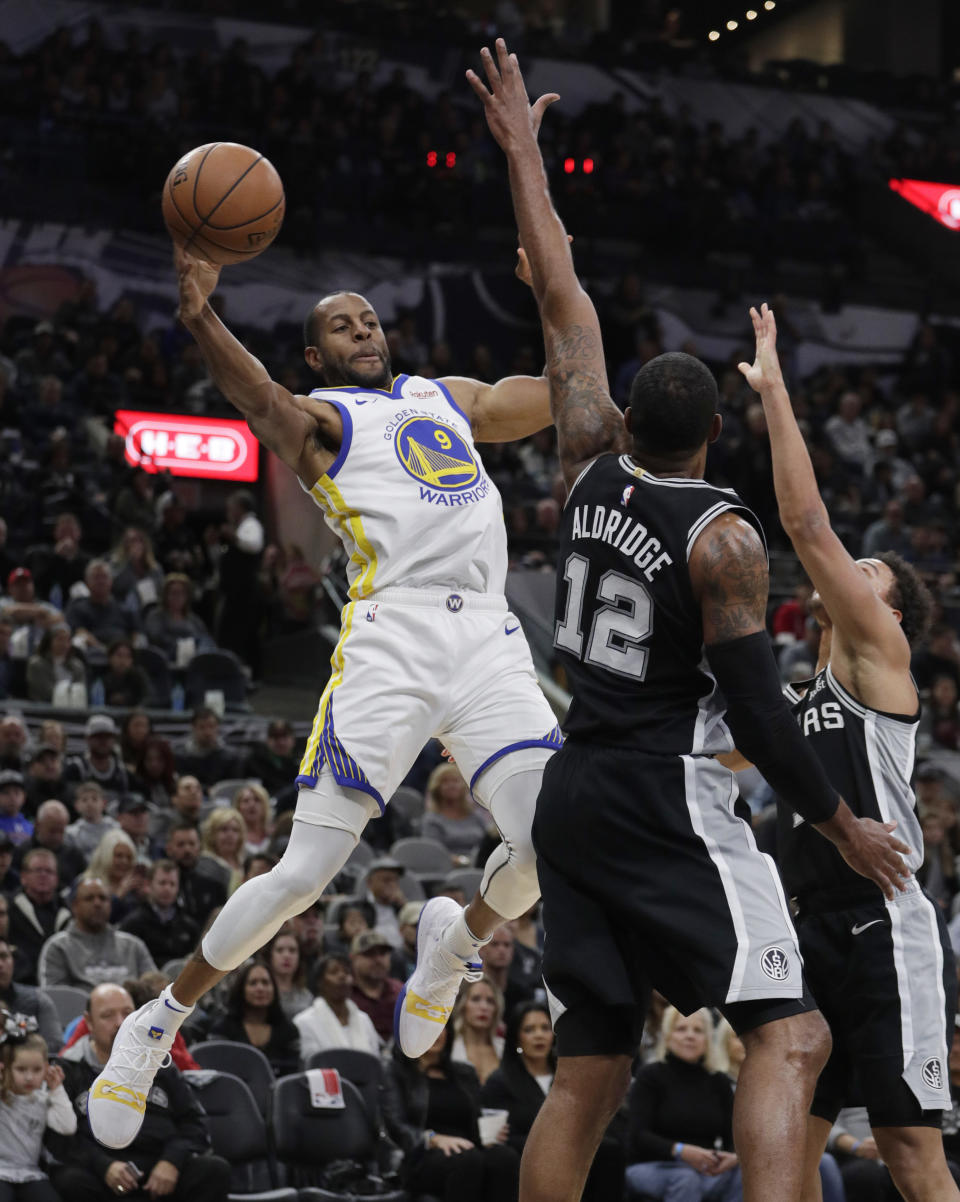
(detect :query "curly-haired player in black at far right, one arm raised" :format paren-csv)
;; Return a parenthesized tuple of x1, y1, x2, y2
(740, 305, 960, 1202)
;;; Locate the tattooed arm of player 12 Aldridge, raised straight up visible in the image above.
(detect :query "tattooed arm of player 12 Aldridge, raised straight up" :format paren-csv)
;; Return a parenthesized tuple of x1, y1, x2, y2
(467, 38, 628, 487)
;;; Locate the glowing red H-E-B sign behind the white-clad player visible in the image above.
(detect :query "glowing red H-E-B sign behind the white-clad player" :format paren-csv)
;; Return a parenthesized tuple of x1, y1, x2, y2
(113, 409, 258, 481)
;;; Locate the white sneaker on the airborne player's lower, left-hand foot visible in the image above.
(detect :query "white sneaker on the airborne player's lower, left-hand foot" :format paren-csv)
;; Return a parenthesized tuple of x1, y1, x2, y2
(87, 998, 179, 1148)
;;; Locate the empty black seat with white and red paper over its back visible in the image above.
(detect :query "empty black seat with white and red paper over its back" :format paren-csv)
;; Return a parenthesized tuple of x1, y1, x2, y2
(270, 1072, 407, 1202)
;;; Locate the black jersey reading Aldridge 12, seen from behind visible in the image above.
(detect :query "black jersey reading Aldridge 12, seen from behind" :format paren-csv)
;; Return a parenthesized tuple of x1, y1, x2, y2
(554, 454, 763, 755)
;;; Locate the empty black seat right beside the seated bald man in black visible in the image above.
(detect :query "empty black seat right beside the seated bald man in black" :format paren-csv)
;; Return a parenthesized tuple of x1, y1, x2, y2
(184, 1069, 298, 1202)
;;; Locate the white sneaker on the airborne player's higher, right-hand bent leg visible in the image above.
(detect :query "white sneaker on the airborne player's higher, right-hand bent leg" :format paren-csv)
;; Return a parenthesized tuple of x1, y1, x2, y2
(393, 898, 483, 1059)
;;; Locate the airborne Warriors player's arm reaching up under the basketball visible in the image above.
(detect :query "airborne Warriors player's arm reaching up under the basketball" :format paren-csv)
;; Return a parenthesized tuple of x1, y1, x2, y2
(173, 246, 317, 471)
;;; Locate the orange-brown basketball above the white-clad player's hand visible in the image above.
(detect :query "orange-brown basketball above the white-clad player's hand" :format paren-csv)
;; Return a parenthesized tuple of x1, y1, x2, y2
(162, 142, 286, 266)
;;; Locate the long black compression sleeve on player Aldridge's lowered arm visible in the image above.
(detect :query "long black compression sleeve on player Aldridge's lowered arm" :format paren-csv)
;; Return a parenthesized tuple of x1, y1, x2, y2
(705, 631, 840, 822)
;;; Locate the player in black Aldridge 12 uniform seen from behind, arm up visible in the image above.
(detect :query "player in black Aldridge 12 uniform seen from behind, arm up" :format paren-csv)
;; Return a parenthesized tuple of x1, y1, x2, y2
(467, 41, 907, 1202)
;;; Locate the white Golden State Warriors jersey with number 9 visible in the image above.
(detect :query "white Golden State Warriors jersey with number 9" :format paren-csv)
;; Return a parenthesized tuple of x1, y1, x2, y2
(304, 375, 507, 601)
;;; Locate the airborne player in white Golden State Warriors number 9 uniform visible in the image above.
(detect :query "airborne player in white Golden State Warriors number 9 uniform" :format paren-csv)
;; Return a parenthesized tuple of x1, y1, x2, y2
(89, 250, 560, 1148)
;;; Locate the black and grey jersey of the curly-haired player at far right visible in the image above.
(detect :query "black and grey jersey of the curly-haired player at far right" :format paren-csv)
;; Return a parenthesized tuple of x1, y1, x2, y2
(777, 665, 923, 898)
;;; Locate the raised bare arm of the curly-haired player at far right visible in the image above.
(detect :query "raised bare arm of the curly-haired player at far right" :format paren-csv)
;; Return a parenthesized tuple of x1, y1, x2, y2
(740, 304, 910, 668)
